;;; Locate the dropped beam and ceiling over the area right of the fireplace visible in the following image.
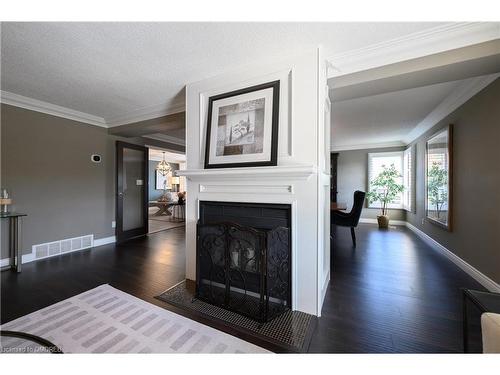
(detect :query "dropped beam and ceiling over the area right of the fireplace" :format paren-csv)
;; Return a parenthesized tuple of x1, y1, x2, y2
(328, 39, 500, 151)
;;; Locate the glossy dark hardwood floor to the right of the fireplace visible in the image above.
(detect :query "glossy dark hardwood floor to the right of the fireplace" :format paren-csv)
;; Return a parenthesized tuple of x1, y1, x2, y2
(309, 224, 484, 353)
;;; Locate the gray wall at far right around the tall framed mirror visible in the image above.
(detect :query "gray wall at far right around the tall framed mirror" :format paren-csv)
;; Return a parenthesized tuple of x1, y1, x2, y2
(407, 79, 500, 282)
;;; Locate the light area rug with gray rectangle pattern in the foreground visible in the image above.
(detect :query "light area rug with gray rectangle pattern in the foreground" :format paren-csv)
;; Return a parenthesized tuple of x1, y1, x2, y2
(0, 285, 268, 353)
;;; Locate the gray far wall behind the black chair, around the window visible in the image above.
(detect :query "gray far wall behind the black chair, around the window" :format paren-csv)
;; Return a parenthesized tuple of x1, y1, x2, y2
(337, 147, 406, 220)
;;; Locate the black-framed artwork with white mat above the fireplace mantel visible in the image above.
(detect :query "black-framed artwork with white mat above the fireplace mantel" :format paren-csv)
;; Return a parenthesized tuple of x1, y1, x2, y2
(205, 81, 280, 168)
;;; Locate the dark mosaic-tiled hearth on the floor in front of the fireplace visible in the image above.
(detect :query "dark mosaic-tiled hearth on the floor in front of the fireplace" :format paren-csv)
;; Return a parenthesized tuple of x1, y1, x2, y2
(156, 281, 316, 353)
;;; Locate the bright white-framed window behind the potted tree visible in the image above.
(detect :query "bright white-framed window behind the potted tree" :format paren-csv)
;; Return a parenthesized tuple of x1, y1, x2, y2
(368, 151, 414, 211)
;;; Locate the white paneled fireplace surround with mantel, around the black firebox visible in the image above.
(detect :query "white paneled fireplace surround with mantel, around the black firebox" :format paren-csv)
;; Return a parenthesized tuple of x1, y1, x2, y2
(178, 49, 330, 316)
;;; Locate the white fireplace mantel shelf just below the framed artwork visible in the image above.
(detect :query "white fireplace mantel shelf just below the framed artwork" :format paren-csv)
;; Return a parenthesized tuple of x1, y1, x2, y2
(176, 165, 316, 181)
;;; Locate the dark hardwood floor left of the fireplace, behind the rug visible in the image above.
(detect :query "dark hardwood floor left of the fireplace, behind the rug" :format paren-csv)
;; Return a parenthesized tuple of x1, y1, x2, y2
(0, 227, 186, 323)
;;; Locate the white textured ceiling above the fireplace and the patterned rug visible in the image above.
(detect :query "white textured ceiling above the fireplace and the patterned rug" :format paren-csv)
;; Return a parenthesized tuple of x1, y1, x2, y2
(1, 22, 443, 125)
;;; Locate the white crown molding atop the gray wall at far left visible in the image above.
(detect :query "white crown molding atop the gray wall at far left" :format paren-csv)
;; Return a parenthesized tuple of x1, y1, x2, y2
(1, 90, 107, 128)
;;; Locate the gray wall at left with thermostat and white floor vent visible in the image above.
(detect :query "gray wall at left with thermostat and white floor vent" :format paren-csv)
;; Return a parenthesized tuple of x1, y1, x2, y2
(1, 104, 168, 259)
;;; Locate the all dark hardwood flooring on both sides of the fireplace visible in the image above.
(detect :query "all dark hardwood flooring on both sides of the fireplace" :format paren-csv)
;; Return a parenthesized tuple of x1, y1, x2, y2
(0, 224, 483, 353)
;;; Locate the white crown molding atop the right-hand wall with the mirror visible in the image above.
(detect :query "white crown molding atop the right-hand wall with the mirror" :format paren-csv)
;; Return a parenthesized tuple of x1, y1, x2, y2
(403, 74, 500, 144)
